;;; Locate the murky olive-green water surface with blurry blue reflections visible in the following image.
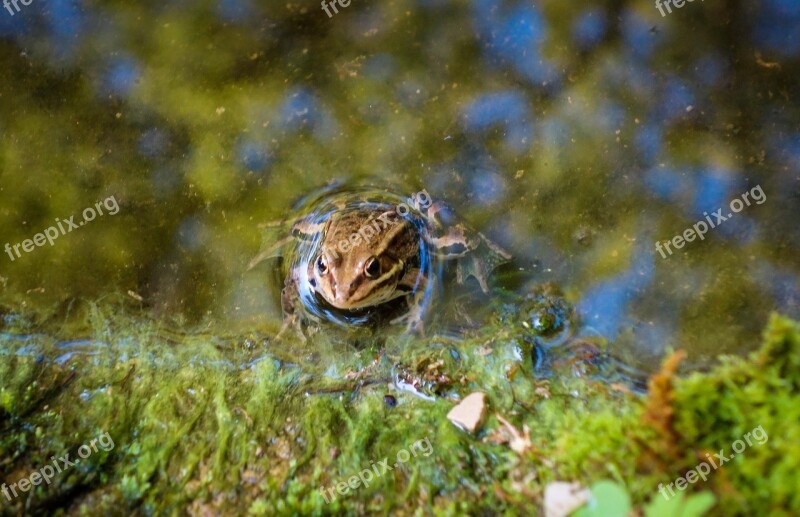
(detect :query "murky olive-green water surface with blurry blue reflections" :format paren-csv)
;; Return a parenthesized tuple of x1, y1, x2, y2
(0, 0, 800, 367)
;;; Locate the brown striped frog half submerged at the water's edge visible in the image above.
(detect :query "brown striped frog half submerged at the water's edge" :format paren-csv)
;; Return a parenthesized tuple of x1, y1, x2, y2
(250, 185, 511, 340)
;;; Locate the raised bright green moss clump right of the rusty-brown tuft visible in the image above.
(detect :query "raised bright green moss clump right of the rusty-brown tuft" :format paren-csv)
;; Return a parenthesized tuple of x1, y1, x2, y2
(676, 316, 800, 514)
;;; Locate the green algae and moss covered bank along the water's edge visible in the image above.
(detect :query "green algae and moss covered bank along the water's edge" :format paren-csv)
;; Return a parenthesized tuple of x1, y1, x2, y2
(0, 296, 800, 515)
